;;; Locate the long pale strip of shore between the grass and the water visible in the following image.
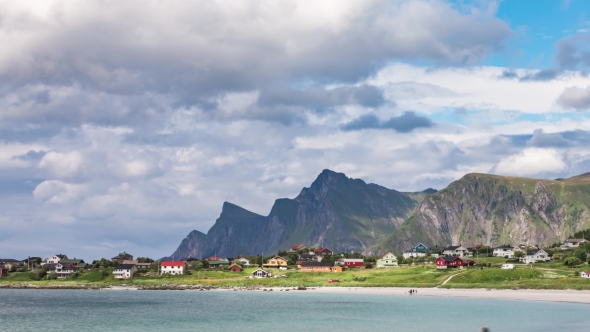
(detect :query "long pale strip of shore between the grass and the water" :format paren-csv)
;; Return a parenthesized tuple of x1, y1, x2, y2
(0, 284, 590, 304)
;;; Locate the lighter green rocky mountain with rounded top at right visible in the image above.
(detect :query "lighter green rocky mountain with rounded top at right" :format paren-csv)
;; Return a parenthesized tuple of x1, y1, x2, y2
(365, 173, 590, 254)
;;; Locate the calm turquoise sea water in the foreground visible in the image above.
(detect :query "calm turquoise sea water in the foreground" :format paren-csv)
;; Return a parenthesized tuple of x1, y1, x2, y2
(0, 289, 590, 332)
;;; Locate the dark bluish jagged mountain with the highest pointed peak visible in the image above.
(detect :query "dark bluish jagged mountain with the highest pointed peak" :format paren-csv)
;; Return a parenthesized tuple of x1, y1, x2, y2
(171, 170, 434, 259)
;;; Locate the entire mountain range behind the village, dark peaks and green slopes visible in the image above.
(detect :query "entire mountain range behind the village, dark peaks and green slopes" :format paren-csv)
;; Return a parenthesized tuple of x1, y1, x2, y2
(166, 170, 590, 259)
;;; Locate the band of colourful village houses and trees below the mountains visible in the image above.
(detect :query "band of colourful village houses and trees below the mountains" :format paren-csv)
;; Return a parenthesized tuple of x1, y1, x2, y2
(0, 239, 590, 283)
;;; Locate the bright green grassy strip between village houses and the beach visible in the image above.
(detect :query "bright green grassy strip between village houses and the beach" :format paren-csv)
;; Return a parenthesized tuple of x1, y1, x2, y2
(0, 258, 590, 289)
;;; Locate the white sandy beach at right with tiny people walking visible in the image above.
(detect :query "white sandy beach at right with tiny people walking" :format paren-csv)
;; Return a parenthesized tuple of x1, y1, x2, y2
(298, 287, 590, 304)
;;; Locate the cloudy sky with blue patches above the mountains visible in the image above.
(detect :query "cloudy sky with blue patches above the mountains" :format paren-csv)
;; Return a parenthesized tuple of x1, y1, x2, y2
(0, 0, 590, 261)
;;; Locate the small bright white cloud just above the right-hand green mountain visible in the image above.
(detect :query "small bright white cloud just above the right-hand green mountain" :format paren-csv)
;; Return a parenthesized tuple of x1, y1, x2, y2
(492, 148, 567, 176)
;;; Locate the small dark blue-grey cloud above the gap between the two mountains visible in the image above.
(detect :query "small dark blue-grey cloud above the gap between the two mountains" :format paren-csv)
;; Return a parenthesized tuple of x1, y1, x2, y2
(341, 112, 434, 133)
